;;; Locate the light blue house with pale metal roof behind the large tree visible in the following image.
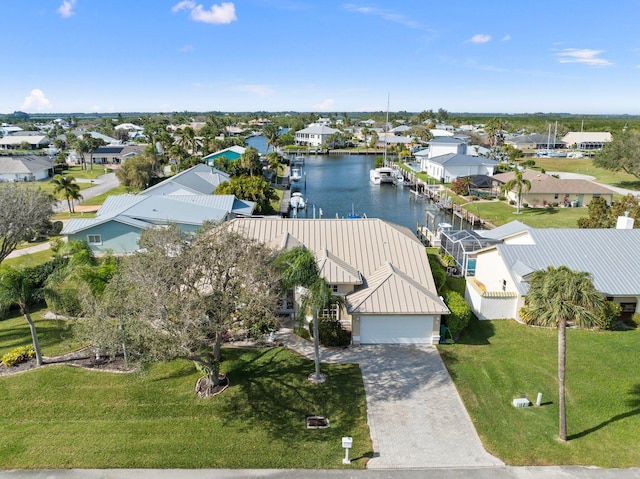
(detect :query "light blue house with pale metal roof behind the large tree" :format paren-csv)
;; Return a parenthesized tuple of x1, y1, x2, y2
(61, 194, 255, 254)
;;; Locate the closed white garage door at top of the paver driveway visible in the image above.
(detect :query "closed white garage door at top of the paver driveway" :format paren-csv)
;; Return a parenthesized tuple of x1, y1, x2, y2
(360, 316, 433, 344)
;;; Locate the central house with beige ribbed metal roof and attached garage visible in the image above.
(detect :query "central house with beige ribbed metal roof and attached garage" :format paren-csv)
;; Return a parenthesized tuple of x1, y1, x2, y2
(229, 217, 449, 345)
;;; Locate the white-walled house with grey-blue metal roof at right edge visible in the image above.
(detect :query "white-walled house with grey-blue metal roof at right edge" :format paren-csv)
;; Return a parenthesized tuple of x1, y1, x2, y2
(465, 224, 640, 319)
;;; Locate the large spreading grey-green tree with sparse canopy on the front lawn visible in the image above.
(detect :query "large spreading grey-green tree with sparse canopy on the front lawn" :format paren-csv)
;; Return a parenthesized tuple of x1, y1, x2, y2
(81, 224, 280, 391)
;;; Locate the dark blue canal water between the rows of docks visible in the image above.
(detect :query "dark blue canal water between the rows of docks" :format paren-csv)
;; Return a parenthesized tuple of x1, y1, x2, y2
(242, 137, 459, 232)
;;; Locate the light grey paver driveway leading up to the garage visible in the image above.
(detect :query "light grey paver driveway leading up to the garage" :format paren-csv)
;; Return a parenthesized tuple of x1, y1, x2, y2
(278, 330, 504, 469)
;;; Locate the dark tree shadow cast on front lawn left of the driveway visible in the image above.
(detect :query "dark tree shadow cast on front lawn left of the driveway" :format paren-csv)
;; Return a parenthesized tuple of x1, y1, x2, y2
(217, 348, 366, 441)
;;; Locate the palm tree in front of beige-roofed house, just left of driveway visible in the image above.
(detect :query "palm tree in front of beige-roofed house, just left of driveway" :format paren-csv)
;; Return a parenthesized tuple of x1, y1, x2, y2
(276, 246, 344, 383)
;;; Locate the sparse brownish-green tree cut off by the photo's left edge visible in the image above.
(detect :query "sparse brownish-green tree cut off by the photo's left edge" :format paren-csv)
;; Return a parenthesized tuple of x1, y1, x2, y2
(0, 182, 53, 262)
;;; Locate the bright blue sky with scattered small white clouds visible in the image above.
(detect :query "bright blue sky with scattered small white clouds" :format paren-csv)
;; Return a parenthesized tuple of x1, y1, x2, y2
(0, 0, 640, 114)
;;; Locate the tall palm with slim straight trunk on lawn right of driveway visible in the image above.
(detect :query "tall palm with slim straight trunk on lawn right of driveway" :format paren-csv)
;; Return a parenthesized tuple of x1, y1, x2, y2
(525, 266, 605, 441)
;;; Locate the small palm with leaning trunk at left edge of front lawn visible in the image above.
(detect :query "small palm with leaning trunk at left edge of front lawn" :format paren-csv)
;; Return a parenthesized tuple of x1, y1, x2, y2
(0, 266, 42, 366)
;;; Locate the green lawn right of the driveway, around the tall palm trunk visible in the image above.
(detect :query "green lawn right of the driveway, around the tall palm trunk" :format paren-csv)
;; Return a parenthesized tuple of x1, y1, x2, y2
(439, 320, 640, 467)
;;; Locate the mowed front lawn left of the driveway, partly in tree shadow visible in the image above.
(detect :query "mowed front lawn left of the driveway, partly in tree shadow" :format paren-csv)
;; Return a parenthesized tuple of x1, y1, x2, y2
(0, 348, 372, 469)
